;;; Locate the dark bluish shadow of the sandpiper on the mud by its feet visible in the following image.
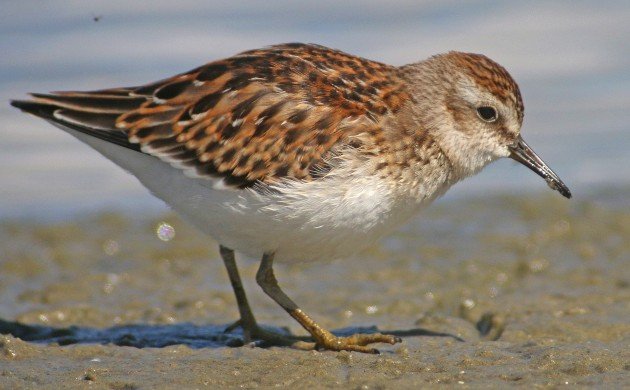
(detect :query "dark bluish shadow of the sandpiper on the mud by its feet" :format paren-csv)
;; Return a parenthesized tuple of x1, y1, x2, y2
(0, 319, 464, 348)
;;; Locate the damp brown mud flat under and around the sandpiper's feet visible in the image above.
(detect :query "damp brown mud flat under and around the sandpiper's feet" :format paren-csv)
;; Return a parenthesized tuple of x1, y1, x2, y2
(0, 189, 630, 389)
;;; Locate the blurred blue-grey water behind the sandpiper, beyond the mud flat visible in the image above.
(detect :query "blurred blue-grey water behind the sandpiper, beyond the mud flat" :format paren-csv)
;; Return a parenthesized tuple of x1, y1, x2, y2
(0, 0, 630, 220)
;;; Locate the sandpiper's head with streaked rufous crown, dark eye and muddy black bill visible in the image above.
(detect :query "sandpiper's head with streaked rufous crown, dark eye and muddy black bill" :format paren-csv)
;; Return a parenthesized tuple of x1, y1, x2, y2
(403, 52, 571, 198)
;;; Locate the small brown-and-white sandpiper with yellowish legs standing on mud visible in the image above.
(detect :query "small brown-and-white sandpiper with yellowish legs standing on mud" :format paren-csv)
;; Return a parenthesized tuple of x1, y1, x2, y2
(12, 44, 571, 353)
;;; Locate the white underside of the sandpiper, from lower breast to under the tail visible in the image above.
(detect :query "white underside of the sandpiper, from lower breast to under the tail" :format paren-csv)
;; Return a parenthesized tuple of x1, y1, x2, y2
(64, 128, 442, 261)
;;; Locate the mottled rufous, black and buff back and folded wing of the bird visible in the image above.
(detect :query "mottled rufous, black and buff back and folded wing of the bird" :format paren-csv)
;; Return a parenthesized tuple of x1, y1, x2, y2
(18, 44, 410, 187)
